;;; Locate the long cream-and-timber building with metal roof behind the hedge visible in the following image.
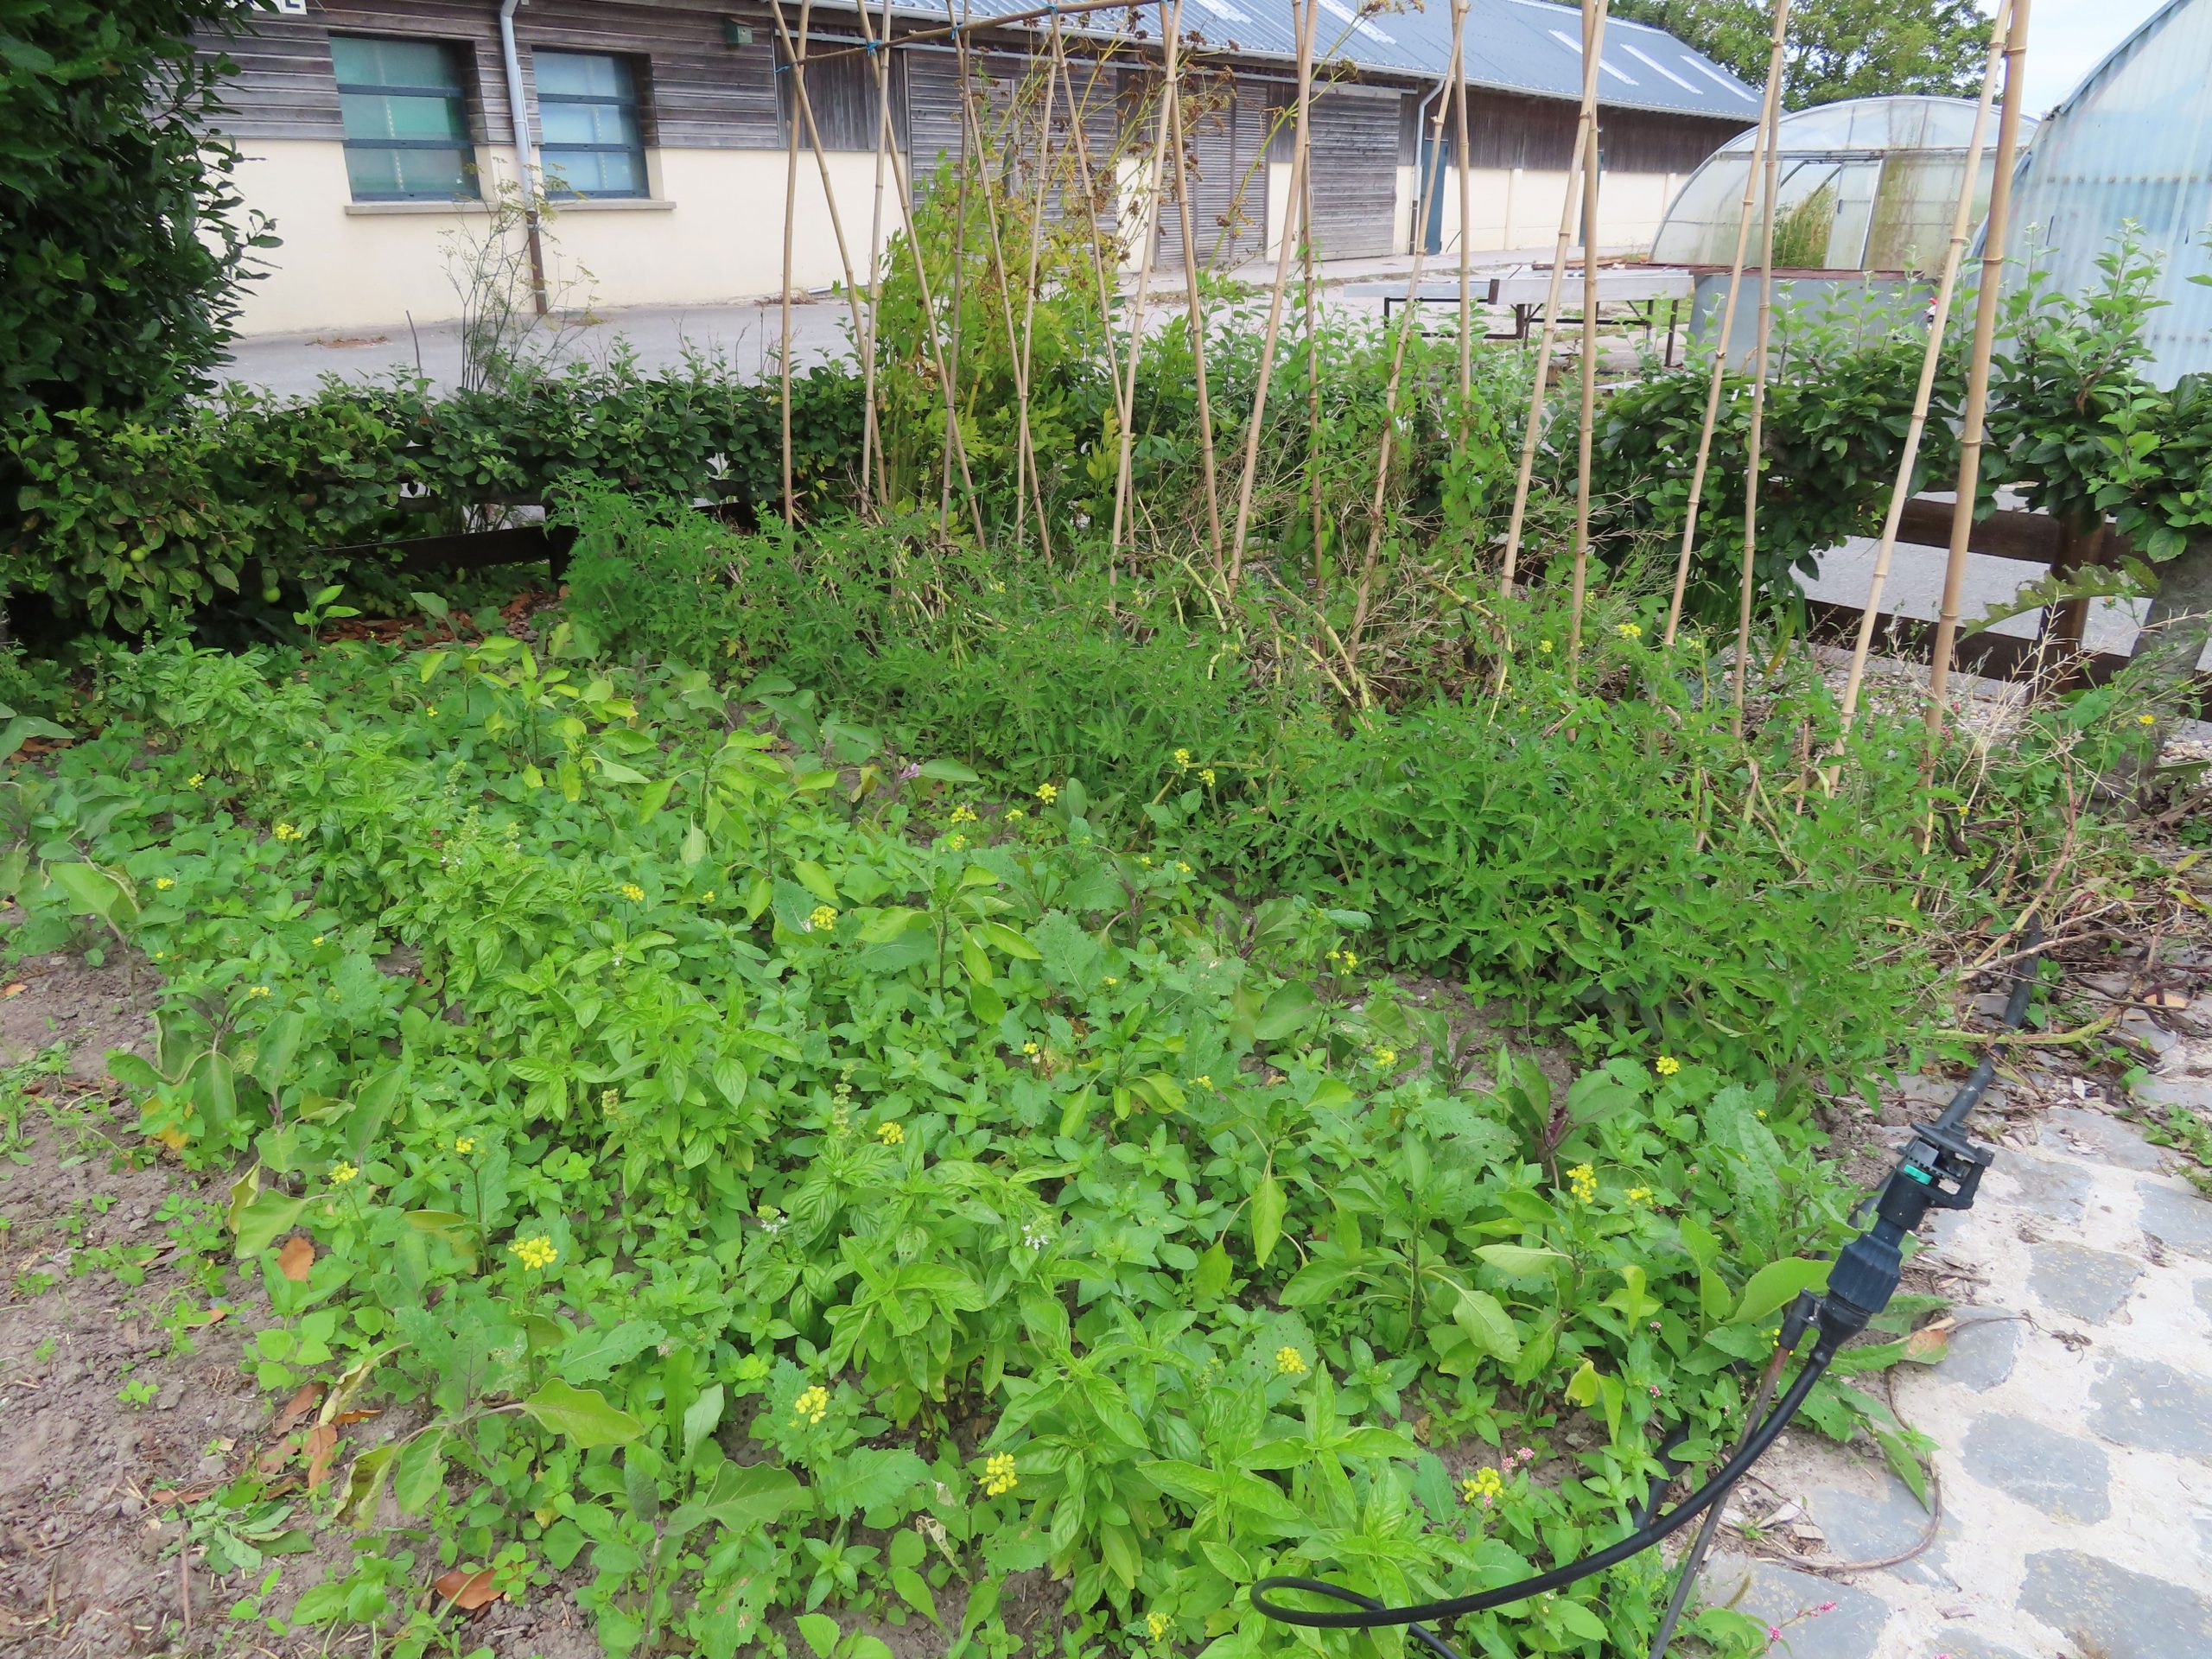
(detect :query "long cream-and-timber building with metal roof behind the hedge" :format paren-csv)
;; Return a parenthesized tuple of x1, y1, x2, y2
(206, 0, 1758, 334)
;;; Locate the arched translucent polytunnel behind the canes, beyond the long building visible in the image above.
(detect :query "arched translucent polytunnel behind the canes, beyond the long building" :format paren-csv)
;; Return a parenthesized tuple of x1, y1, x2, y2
(1652, 98, 2031, 274)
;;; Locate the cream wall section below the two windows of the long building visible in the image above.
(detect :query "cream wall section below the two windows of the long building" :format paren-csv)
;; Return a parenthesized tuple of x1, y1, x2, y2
(238, 139, 898, 334)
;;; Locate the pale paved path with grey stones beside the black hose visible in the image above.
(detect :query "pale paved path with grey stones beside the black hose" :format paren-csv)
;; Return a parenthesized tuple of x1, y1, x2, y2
(1706, 986, 2212, 1659)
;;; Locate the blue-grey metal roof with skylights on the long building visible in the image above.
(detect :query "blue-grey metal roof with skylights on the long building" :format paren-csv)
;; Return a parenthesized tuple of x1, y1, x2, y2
(823, 0, 1758, 122)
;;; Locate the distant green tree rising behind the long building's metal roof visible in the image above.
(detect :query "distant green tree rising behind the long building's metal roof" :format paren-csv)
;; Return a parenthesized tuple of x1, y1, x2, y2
(1612, 0, 1988, 108)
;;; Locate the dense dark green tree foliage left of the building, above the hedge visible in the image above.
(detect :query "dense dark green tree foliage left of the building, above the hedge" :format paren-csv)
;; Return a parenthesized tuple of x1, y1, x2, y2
(0, 0, 268, 418)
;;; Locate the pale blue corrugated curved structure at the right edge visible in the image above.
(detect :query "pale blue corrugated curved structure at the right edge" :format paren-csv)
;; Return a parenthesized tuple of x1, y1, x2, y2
(2006, 0, 2212, 385)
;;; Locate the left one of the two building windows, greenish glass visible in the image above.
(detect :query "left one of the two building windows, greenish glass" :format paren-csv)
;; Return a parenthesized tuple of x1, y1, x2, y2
(329, 35, 478, 201)
